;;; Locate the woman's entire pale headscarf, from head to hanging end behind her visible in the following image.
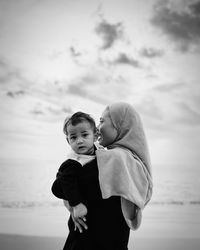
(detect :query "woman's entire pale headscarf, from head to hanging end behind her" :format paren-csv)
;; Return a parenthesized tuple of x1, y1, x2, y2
(96, 102, 153, 230)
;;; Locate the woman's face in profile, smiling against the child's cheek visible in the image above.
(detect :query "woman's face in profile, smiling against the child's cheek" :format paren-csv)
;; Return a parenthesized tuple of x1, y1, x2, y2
(97, 109, 118, 147)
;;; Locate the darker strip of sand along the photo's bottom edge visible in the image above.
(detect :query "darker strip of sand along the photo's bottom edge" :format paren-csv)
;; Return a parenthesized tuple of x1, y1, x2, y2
(0, 234, 200, 250)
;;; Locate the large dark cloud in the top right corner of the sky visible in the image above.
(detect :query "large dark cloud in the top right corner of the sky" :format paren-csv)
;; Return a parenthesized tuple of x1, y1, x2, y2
(151, 1, 200, 52)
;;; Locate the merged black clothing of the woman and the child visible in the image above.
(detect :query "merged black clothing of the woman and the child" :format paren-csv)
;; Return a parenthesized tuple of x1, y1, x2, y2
(52, 159, 130, 250)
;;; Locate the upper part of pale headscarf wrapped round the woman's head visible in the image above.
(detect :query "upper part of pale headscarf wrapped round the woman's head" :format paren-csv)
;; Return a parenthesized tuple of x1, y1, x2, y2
(107, 102, 151, 174)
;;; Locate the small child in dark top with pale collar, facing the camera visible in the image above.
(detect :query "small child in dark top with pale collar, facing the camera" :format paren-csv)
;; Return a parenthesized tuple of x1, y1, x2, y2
(52, 112, 97, 220)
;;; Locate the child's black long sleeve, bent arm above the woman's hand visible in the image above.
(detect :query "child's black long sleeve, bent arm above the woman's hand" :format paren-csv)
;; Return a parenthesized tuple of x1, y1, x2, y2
(52, 159, 82, 206)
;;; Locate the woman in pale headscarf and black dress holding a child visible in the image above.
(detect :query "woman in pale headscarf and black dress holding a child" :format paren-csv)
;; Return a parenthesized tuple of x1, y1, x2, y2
(64, 103, 152, 250)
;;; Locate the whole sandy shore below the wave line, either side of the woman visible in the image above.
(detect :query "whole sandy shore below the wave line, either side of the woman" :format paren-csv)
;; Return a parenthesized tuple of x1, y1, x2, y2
(0, 204, 200, 250)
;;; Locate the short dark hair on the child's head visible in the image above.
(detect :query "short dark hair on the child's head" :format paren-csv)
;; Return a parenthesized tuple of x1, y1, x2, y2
(63, 111, 97, 135)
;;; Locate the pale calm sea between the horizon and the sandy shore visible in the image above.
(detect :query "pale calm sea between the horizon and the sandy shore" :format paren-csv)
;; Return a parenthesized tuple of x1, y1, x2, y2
(0, 158, 200, 208)
